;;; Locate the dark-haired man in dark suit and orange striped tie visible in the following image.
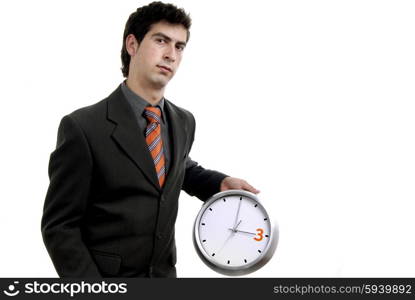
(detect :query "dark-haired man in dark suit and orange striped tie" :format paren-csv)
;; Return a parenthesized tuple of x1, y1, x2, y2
(42, 2, 258, 277)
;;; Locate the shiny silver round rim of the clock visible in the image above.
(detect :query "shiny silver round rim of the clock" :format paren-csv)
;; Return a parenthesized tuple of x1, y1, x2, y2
(193, 190, 279, 276)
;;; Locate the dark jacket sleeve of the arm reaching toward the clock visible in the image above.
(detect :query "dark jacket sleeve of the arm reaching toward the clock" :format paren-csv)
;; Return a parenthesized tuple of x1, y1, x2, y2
(182, 114, 228, 201)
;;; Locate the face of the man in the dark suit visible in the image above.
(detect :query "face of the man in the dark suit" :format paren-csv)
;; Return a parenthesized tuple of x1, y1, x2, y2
(127, 22, 187, 88)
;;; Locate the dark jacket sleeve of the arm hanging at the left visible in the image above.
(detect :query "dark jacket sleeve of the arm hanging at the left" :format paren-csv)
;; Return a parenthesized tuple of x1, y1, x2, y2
(41, 116, 101, 277)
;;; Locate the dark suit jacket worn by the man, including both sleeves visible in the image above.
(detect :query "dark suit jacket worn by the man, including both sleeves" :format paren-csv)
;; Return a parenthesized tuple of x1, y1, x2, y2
(42, 87, 226, 277)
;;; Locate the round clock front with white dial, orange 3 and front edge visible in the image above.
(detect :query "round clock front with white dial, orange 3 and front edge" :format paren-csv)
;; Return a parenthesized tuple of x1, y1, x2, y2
(194, 191, 274, 273)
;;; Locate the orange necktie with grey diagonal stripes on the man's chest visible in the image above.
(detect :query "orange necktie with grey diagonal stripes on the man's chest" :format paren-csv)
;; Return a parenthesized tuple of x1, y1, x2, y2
(144, 106, 166, 187)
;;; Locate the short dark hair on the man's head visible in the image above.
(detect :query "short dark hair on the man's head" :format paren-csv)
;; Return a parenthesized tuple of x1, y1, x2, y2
(121, 1, 192, 77)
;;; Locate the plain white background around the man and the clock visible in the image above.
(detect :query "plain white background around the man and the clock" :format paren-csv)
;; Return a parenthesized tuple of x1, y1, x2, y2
(0, 0, 415, 277)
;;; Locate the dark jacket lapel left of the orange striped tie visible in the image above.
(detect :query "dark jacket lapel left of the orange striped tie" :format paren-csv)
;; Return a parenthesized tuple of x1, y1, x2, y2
(107, 86, 160, 189)
